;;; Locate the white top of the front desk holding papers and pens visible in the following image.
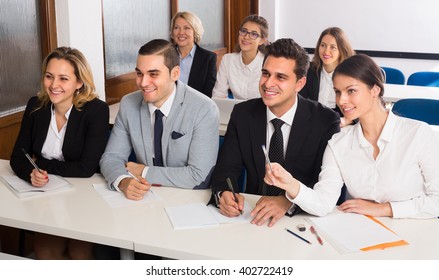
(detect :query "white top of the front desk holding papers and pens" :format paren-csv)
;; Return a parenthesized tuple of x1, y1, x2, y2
(0, 160, 439, 260)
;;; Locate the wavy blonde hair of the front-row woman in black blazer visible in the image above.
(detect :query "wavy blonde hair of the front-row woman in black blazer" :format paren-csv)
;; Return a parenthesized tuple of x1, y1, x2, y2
(37, 47, 98, 111)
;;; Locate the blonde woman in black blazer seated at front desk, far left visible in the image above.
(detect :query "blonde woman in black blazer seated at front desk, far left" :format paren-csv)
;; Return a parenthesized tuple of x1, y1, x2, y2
(10, 47, 109, 259)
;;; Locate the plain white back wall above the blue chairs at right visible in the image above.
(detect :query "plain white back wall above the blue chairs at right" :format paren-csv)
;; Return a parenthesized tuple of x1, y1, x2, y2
(259, 0, 439, 78)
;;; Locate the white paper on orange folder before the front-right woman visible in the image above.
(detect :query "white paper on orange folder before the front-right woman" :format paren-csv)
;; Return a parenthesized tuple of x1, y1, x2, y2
(308, 212, 408, 253)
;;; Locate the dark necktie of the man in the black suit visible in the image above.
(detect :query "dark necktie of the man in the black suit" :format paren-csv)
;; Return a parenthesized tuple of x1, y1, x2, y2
(267, 119, 284, 196)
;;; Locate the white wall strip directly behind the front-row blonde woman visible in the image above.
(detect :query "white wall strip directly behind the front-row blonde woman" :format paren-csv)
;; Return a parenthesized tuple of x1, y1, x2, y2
(55, 0, 105, 100)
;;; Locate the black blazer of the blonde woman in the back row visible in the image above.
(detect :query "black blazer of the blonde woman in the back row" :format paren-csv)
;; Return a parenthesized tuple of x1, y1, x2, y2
(188, 45, 216, 97)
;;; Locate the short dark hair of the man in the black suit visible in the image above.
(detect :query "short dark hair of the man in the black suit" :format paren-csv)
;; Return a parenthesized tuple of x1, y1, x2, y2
(264, 38, 309, 79)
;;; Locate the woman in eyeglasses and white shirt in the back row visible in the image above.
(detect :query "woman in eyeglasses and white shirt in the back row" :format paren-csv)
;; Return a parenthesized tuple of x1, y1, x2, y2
(212, 15, 268, 100)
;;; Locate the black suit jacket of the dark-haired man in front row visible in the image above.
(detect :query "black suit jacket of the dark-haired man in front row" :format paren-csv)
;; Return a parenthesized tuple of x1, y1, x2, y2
(212, 95, 340, 199)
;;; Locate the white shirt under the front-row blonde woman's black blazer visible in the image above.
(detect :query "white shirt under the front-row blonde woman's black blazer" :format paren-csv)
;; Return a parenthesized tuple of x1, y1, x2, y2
(41, 105, 73, 161)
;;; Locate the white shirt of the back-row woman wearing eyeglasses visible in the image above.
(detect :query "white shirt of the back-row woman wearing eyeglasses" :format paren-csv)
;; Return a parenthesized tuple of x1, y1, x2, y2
(212, 52, 264, 100)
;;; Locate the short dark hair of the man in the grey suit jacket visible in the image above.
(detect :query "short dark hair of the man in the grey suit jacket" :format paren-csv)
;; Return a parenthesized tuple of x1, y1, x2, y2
(139, 39, 180, 71)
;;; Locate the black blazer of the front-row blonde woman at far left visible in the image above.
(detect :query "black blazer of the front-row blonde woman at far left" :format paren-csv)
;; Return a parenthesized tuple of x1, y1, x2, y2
(10, 96, 109, 182)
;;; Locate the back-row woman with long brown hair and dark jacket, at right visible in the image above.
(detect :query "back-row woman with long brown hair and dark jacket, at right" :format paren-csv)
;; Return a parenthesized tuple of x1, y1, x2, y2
(299, 27, 355, 126)
